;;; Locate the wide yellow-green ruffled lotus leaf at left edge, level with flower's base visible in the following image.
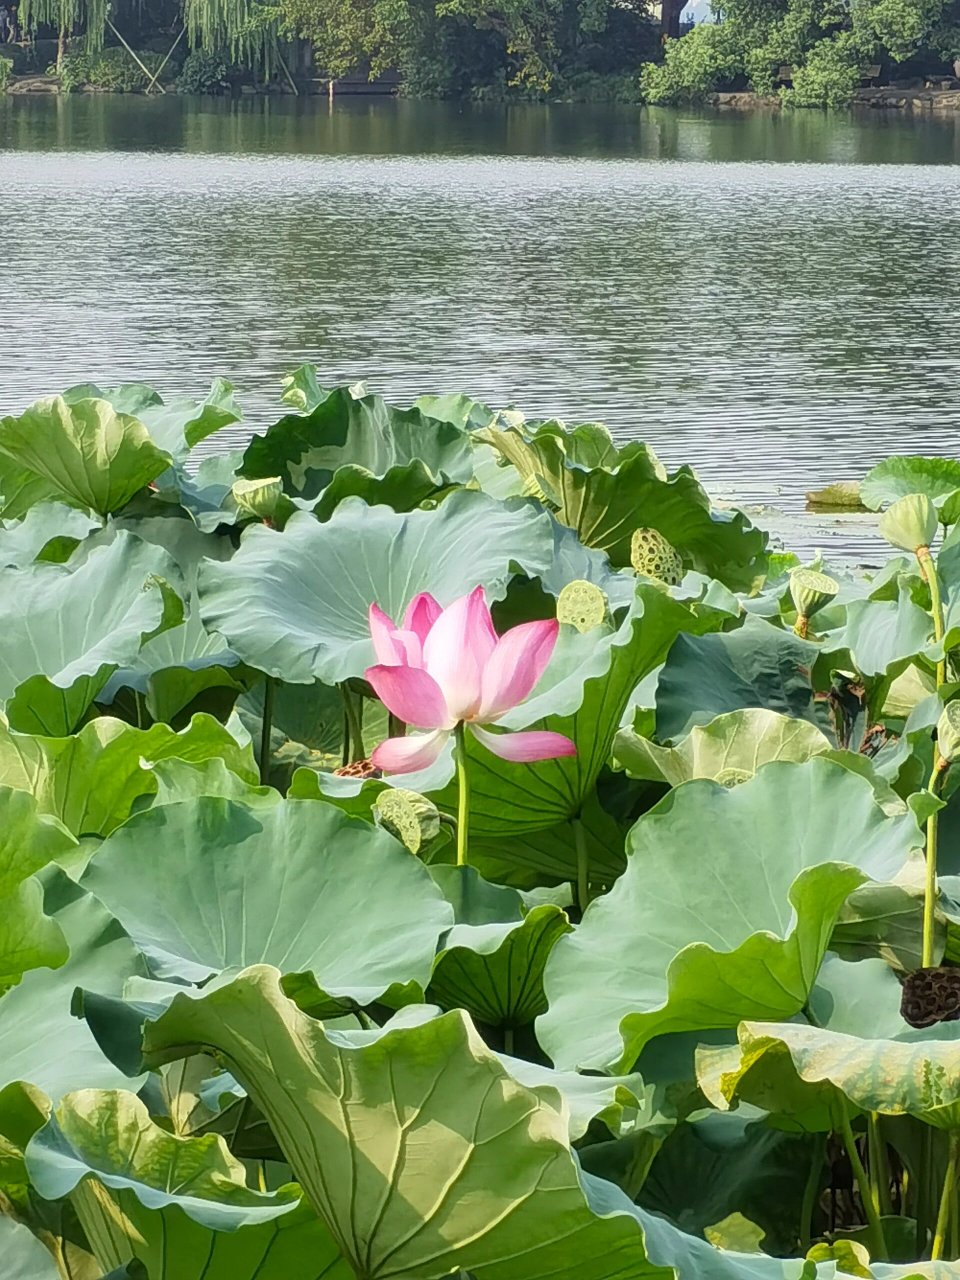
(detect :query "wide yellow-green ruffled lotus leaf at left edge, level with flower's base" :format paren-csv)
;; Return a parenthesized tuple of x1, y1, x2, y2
(0, 716, 257, 836)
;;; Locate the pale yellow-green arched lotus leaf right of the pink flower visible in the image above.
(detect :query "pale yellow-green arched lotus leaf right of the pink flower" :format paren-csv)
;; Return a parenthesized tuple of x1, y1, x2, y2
(613, 707, 831, 787)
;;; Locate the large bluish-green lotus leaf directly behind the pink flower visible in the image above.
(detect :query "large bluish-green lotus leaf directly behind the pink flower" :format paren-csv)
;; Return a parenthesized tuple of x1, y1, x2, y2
(200, 492, 553, 685)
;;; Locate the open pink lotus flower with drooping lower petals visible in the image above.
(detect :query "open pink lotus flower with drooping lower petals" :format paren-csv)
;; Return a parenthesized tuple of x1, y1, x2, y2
(366, 586, 576, 773)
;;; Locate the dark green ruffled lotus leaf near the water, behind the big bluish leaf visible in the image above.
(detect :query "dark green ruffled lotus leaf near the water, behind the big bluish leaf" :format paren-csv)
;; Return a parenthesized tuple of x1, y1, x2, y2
(241, 387, 474, 499)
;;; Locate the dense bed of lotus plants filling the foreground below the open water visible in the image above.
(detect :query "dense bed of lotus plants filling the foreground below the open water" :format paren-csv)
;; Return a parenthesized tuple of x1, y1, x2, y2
(0, 367, 960, 1280)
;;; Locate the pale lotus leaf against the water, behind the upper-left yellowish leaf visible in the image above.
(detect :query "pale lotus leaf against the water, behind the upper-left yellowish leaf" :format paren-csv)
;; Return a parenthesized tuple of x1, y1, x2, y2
(63, 378, 243, 458)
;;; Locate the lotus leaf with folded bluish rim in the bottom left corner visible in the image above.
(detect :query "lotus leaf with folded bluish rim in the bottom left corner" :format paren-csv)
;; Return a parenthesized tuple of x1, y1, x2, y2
(26, 1089, 352, 1280)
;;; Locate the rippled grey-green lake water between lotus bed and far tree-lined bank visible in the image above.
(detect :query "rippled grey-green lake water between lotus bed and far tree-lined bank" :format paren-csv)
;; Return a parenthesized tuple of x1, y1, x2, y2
(0, 96, 960, 559)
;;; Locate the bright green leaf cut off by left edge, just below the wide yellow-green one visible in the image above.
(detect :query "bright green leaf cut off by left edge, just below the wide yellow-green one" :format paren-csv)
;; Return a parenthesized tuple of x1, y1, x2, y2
(0, 786, 76, 977)
